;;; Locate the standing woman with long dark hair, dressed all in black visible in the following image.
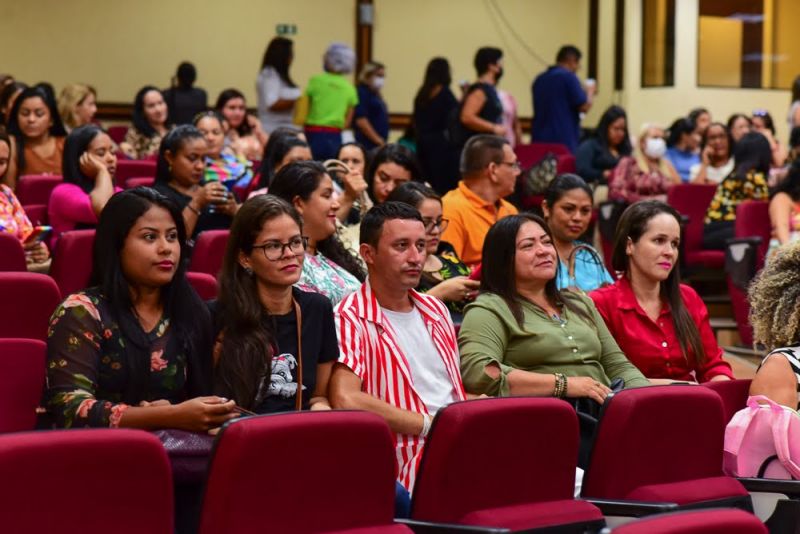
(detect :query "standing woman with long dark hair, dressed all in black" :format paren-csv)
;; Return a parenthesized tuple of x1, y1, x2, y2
(414, 57, 458, 194)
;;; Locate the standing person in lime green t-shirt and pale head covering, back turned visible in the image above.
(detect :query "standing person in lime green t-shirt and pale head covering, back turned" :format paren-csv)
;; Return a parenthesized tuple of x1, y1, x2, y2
(305, 43, 358, 160)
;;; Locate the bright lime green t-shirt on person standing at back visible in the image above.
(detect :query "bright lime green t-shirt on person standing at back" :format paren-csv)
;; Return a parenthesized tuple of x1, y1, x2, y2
(306, 72, 358, 129)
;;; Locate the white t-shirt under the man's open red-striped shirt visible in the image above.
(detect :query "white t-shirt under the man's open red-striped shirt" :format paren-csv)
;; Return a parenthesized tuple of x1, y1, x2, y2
(381, 307, 458, 415)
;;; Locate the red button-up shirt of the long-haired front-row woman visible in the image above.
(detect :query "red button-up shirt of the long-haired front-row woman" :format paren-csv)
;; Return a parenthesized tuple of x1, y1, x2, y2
(589, 277, 733, 382)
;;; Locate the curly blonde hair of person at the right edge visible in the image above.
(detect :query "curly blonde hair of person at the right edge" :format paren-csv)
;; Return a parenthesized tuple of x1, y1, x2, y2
(748, 243, 800, 350)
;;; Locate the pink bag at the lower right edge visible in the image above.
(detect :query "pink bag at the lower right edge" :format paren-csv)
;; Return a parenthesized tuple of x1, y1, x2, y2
(723, 395, 800, 480)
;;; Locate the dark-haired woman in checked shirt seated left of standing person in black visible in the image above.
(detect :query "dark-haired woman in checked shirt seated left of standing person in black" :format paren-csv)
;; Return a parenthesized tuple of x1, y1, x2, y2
(119, 85, 170, 159)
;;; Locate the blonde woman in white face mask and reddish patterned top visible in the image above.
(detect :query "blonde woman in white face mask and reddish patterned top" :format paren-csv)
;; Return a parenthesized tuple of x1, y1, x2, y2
(608, 124, 681, 203)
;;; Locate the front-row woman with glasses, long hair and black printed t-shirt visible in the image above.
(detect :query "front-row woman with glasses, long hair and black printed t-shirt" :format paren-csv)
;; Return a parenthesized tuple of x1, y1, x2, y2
(213, 195, 339, 413)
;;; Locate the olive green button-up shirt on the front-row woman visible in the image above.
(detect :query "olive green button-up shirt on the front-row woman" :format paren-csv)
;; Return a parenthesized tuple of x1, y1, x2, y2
(458, 293, 649, 397)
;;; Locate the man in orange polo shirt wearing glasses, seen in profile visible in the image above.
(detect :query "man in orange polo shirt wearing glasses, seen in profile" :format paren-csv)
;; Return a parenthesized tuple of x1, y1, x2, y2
(442, 135, 520, 267)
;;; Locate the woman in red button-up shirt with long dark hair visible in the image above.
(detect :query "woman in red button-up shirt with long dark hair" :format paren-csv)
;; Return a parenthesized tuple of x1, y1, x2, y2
(590, 200, 733, 384)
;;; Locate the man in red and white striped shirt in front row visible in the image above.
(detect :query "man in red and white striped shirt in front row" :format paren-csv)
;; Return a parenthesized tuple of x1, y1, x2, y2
(330, 202, 466, 490)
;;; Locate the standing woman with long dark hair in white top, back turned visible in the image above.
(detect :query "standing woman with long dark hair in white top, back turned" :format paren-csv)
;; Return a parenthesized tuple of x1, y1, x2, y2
(256, 37, 301, 133)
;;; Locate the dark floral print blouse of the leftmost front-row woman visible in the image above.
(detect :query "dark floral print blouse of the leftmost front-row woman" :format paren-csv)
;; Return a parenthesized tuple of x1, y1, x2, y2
(45, 288, 187, 428)
